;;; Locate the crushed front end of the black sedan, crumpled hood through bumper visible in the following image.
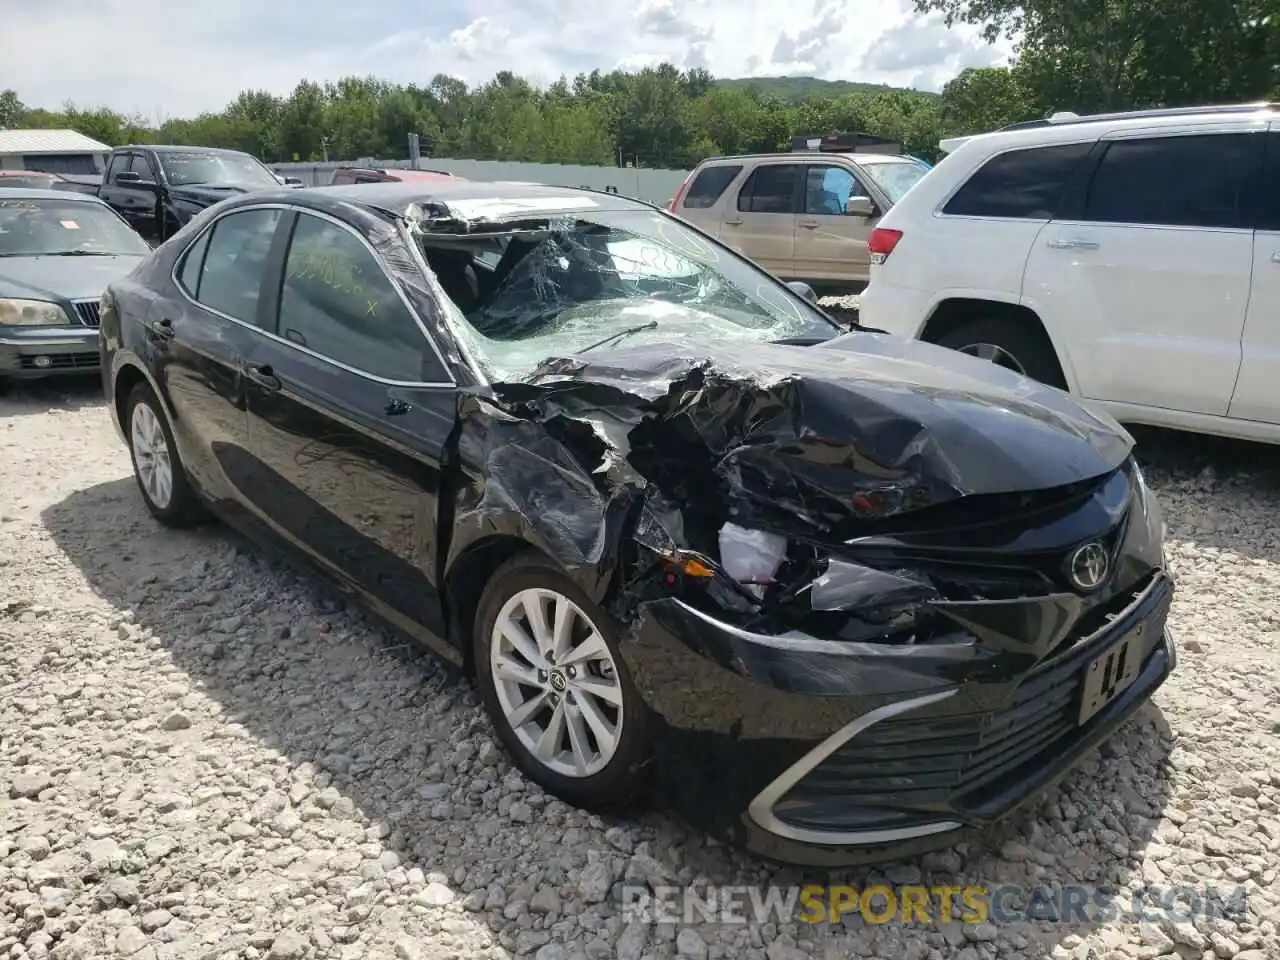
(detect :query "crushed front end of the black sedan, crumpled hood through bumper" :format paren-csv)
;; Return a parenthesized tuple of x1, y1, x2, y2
(463, 334, 1175, 867)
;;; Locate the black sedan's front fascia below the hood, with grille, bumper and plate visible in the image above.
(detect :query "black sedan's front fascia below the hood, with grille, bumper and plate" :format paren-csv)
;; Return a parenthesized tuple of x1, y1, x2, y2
(628, 460, 1175, 867)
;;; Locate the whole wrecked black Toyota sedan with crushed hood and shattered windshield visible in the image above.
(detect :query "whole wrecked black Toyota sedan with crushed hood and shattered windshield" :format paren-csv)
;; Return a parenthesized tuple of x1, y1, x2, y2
(101, 183, 1175, 865)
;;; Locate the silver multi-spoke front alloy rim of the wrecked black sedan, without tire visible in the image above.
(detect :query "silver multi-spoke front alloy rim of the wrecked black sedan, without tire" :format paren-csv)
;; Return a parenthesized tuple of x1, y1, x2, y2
(489, 588, 623, 778)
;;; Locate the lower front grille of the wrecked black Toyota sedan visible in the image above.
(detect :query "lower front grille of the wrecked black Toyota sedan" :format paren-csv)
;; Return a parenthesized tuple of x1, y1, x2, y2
(774, 570, 1172, 831)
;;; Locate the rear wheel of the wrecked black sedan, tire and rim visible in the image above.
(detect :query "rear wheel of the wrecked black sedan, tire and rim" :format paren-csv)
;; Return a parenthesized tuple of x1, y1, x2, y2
(124, 383, 207, 529)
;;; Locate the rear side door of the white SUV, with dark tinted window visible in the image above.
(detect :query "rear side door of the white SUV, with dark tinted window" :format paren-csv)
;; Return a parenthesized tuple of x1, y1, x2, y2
(1023, 131, 1265, 416)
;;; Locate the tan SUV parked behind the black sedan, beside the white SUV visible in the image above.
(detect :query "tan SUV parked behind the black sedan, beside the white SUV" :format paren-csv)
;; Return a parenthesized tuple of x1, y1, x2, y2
(668, 138, 929, 289)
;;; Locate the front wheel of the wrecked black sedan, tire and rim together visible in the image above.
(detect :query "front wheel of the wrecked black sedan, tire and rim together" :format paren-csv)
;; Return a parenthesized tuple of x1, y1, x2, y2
(472, 553, 649, 810)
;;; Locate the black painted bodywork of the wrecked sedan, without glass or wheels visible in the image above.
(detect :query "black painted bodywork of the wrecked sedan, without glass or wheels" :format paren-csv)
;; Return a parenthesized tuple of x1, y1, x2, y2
(102, 184, 1174, 865)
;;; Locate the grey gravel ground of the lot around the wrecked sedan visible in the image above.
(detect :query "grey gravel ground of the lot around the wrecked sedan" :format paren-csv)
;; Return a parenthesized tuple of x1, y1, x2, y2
(0, 384, 1280, 960)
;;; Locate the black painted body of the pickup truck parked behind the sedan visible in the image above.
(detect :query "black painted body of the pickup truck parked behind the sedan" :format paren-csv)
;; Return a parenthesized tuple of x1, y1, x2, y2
(97, 145, 279, 244)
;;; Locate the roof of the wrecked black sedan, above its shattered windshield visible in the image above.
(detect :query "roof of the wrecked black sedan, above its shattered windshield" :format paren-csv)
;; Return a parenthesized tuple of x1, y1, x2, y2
(273, 177, 654, 219)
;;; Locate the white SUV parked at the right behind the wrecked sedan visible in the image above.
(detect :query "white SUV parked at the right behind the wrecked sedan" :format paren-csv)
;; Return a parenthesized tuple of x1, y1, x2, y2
(860, 104, 1280, 443)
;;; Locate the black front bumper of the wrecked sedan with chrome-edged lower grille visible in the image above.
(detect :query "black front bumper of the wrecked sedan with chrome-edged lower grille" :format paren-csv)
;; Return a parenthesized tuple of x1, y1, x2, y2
(628, 572, 1175, 868)
